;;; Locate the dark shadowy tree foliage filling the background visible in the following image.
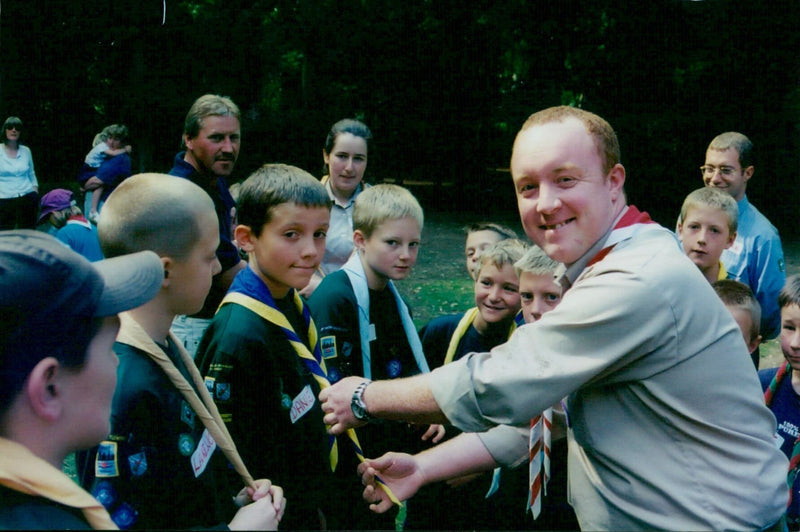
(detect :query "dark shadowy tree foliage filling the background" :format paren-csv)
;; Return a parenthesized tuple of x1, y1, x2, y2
(0, 0, 800, 234)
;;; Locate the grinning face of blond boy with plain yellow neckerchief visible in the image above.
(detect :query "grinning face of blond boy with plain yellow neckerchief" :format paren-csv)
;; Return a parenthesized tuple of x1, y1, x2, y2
(475, 264, 519, 323)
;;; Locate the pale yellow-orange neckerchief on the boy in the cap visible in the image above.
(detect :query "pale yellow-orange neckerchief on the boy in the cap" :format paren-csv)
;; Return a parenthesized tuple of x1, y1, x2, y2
(0, 438, 118, 530)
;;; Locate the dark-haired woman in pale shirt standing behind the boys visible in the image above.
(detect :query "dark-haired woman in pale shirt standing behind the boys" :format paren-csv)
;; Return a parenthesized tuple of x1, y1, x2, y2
(300, 118, 372, 297)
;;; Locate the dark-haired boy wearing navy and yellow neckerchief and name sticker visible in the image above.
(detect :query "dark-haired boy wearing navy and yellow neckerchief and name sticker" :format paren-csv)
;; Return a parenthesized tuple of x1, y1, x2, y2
(197, 164, 336, 530)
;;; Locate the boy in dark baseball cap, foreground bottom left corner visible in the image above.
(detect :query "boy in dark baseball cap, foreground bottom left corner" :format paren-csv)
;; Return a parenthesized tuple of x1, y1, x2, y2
(0, 231, 164, 530)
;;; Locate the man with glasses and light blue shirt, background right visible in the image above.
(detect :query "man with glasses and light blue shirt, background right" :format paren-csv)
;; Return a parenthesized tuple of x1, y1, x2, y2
(700, 131, 786, 340)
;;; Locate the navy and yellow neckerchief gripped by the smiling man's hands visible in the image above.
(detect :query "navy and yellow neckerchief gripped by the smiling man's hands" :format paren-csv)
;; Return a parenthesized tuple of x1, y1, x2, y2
(219, 290, 403, 507)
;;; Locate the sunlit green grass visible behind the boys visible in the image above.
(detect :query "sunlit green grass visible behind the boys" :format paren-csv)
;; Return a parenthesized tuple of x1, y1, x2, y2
(397, 208, 800, 369)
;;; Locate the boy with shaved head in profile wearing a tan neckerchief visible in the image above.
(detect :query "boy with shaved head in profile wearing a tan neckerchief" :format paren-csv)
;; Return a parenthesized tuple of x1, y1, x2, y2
(84, 174, 283, 530)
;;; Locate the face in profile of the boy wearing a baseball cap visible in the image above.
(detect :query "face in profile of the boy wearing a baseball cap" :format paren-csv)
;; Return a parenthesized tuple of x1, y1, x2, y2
(62, 316, 119, 449)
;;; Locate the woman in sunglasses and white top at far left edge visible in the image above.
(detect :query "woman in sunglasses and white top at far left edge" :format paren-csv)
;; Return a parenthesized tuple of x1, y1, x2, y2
(0, 116, 39, 229)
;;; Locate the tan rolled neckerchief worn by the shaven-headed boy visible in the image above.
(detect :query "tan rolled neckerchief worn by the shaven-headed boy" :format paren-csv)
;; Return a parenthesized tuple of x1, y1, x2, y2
(117, 312, 256, 489)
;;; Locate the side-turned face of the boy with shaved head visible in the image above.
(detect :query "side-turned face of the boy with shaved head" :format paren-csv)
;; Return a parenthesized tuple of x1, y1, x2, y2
(165, 210, 222, 314)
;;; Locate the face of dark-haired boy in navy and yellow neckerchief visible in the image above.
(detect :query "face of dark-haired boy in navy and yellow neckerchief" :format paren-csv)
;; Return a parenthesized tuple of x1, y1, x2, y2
(236, 203, 331, 298)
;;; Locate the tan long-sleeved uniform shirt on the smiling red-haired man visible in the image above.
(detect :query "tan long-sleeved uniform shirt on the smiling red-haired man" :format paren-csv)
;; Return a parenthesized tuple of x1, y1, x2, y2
(431, 219, 788, 530)
